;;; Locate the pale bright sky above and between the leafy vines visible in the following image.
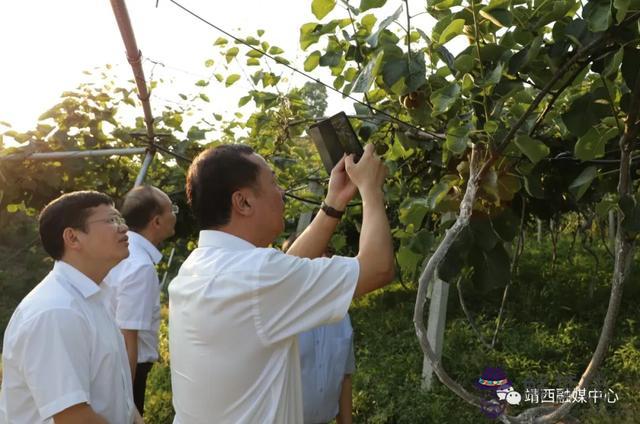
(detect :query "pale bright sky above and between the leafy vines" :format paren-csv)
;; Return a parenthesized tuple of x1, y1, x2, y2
(0, 0, 436, 137)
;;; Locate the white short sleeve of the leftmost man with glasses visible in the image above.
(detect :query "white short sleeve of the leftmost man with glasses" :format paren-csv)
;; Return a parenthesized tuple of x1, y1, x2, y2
(20, 309, 91, 418)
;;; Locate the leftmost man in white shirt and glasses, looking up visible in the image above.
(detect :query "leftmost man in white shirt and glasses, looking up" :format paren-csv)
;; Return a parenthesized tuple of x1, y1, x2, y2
(0, 191, 142, 424)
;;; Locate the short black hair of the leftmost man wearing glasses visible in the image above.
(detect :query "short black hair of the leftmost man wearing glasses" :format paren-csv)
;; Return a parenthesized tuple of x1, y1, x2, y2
(38, 191, 113, 260)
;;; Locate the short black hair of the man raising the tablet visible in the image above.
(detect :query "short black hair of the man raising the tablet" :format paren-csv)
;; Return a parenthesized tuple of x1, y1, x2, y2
(187, 144, 260, 229)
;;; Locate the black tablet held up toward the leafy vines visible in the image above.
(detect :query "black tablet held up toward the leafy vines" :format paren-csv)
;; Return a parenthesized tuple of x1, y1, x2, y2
(308, 112, 364, 174)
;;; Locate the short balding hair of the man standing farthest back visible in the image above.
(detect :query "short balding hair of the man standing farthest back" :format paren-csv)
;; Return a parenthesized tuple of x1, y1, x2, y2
(119, 185, 163, 232)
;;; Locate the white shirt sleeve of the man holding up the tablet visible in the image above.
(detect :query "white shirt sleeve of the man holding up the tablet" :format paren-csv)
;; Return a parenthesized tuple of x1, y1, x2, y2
(253, 249, 360, 344)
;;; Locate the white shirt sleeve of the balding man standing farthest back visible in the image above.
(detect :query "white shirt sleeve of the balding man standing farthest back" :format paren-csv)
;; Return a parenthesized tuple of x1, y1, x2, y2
(115, 264, 159, 330)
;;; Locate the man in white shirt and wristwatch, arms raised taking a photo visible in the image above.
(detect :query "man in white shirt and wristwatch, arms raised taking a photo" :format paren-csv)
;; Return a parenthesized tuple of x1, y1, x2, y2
(169, 145, 394, 424)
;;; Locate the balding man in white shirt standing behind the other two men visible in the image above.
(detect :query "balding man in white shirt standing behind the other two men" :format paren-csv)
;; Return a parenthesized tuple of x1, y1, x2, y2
(105, 186, 177, 415)
